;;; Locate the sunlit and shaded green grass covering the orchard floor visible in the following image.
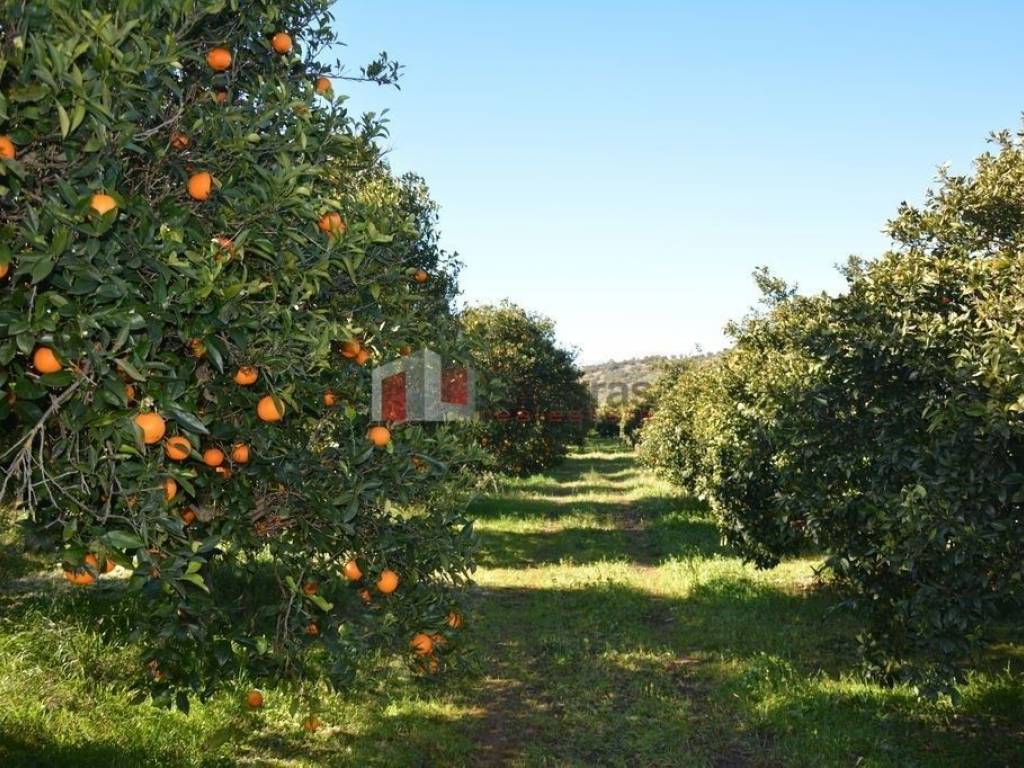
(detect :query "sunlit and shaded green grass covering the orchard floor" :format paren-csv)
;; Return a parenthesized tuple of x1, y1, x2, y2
(0, 444, 1024, 768)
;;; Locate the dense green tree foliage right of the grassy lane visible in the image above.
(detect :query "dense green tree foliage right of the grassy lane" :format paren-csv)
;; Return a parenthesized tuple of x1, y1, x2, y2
(643, 134, 1024, 683)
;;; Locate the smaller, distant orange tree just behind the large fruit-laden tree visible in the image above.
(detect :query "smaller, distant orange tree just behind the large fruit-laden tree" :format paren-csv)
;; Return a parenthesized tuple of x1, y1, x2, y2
(462, 303, 594, 475)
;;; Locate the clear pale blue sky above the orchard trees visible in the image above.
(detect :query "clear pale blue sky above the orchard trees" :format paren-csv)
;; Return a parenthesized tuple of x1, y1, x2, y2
(327, 0, 1024, 362)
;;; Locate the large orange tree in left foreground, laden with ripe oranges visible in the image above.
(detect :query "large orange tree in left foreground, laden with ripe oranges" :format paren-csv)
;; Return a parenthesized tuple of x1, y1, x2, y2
(0, 0, 472, 707)
